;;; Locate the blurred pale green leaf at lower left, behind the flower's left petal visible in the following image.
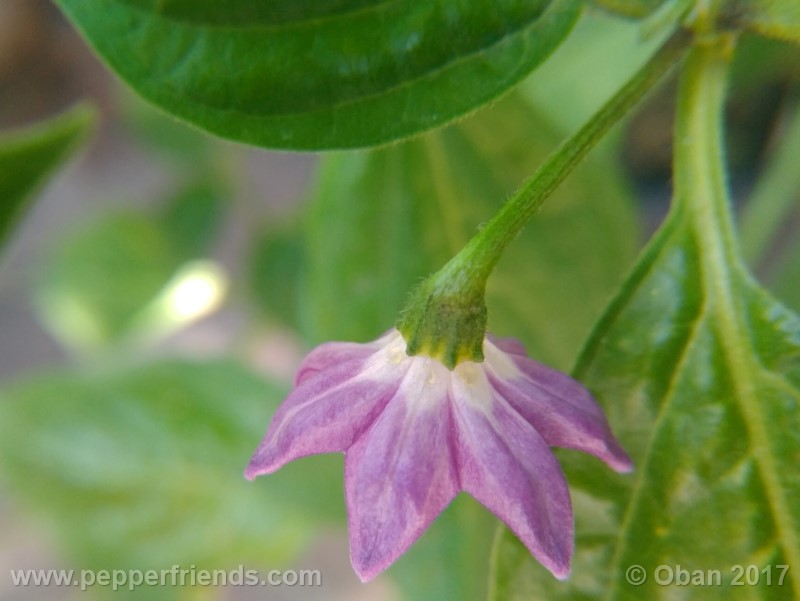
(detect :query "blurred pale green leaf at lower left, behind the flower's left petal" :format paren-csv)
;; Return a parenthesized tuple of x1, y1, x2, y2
(0, 360, 344, 569)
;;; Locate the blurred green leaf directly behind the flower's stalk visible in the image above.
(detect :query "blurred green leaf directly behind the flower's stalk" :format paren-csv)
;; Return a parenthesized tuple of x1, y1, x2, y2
(303, 91, 636, 367)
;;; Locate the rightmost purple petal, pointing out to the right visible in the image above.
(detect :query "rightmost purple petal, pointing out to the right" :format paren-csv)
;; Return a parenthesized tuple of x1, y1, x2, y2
(485, 344, 633, 472)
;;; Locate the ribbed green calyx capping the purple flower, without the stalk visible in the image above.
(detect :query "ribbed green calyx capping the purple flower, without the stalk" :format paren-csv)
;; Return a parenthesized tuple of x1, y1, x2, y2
(397, 255, 486, 370)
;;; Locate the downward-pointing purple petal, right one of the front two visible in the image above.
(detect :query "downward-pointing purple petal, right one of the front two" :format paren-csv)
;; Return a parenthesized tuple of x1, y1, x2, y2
(452, 364, 573, 579)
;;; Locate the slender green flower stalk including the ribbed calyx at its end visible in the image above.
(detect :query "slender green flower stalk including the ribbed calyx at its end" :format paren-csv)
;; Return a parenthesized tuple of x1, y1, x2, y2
(397, 30, 691, 369)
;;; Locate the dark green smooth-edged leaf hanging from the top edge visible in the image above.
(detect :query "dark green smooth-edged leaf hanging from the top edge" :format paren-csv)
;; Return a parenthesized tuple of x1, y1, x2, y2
(57, 0, 579, 149)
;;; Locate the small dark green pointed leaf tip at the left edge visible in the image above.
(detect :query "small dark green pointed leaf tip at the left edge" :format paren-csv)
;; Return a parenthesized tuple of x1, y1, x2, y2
(0, 104, 95, 250)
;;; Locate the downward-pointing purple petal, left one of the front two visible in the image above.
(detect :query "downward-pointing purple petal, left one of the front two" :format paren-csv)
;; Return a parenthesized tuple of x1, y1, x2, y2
(345, 357, 459, 581)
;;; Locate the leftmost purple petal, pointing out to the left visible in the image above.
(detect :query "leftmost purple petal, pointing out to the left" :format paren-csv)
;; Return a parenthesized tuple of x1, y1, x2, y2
(245, 348, 408, 480)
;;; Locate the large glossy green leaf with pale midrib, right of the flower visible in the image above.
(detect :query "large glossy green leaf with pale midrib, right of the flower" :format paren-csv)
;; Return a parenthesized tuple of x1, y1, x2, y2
(491, 41, 800, 601)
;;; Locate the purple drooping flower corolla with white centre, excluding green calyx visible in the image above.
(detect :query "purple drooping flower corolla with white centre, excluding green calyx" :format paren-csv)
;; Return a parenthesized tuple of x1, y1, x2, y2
(245, 329, 632, 581)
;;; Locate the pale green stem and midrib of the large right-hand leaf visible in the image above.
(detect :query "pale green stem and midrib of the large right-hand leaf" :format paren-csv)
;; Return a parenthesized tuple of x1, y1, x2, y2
(679, 41, 800, 584)
